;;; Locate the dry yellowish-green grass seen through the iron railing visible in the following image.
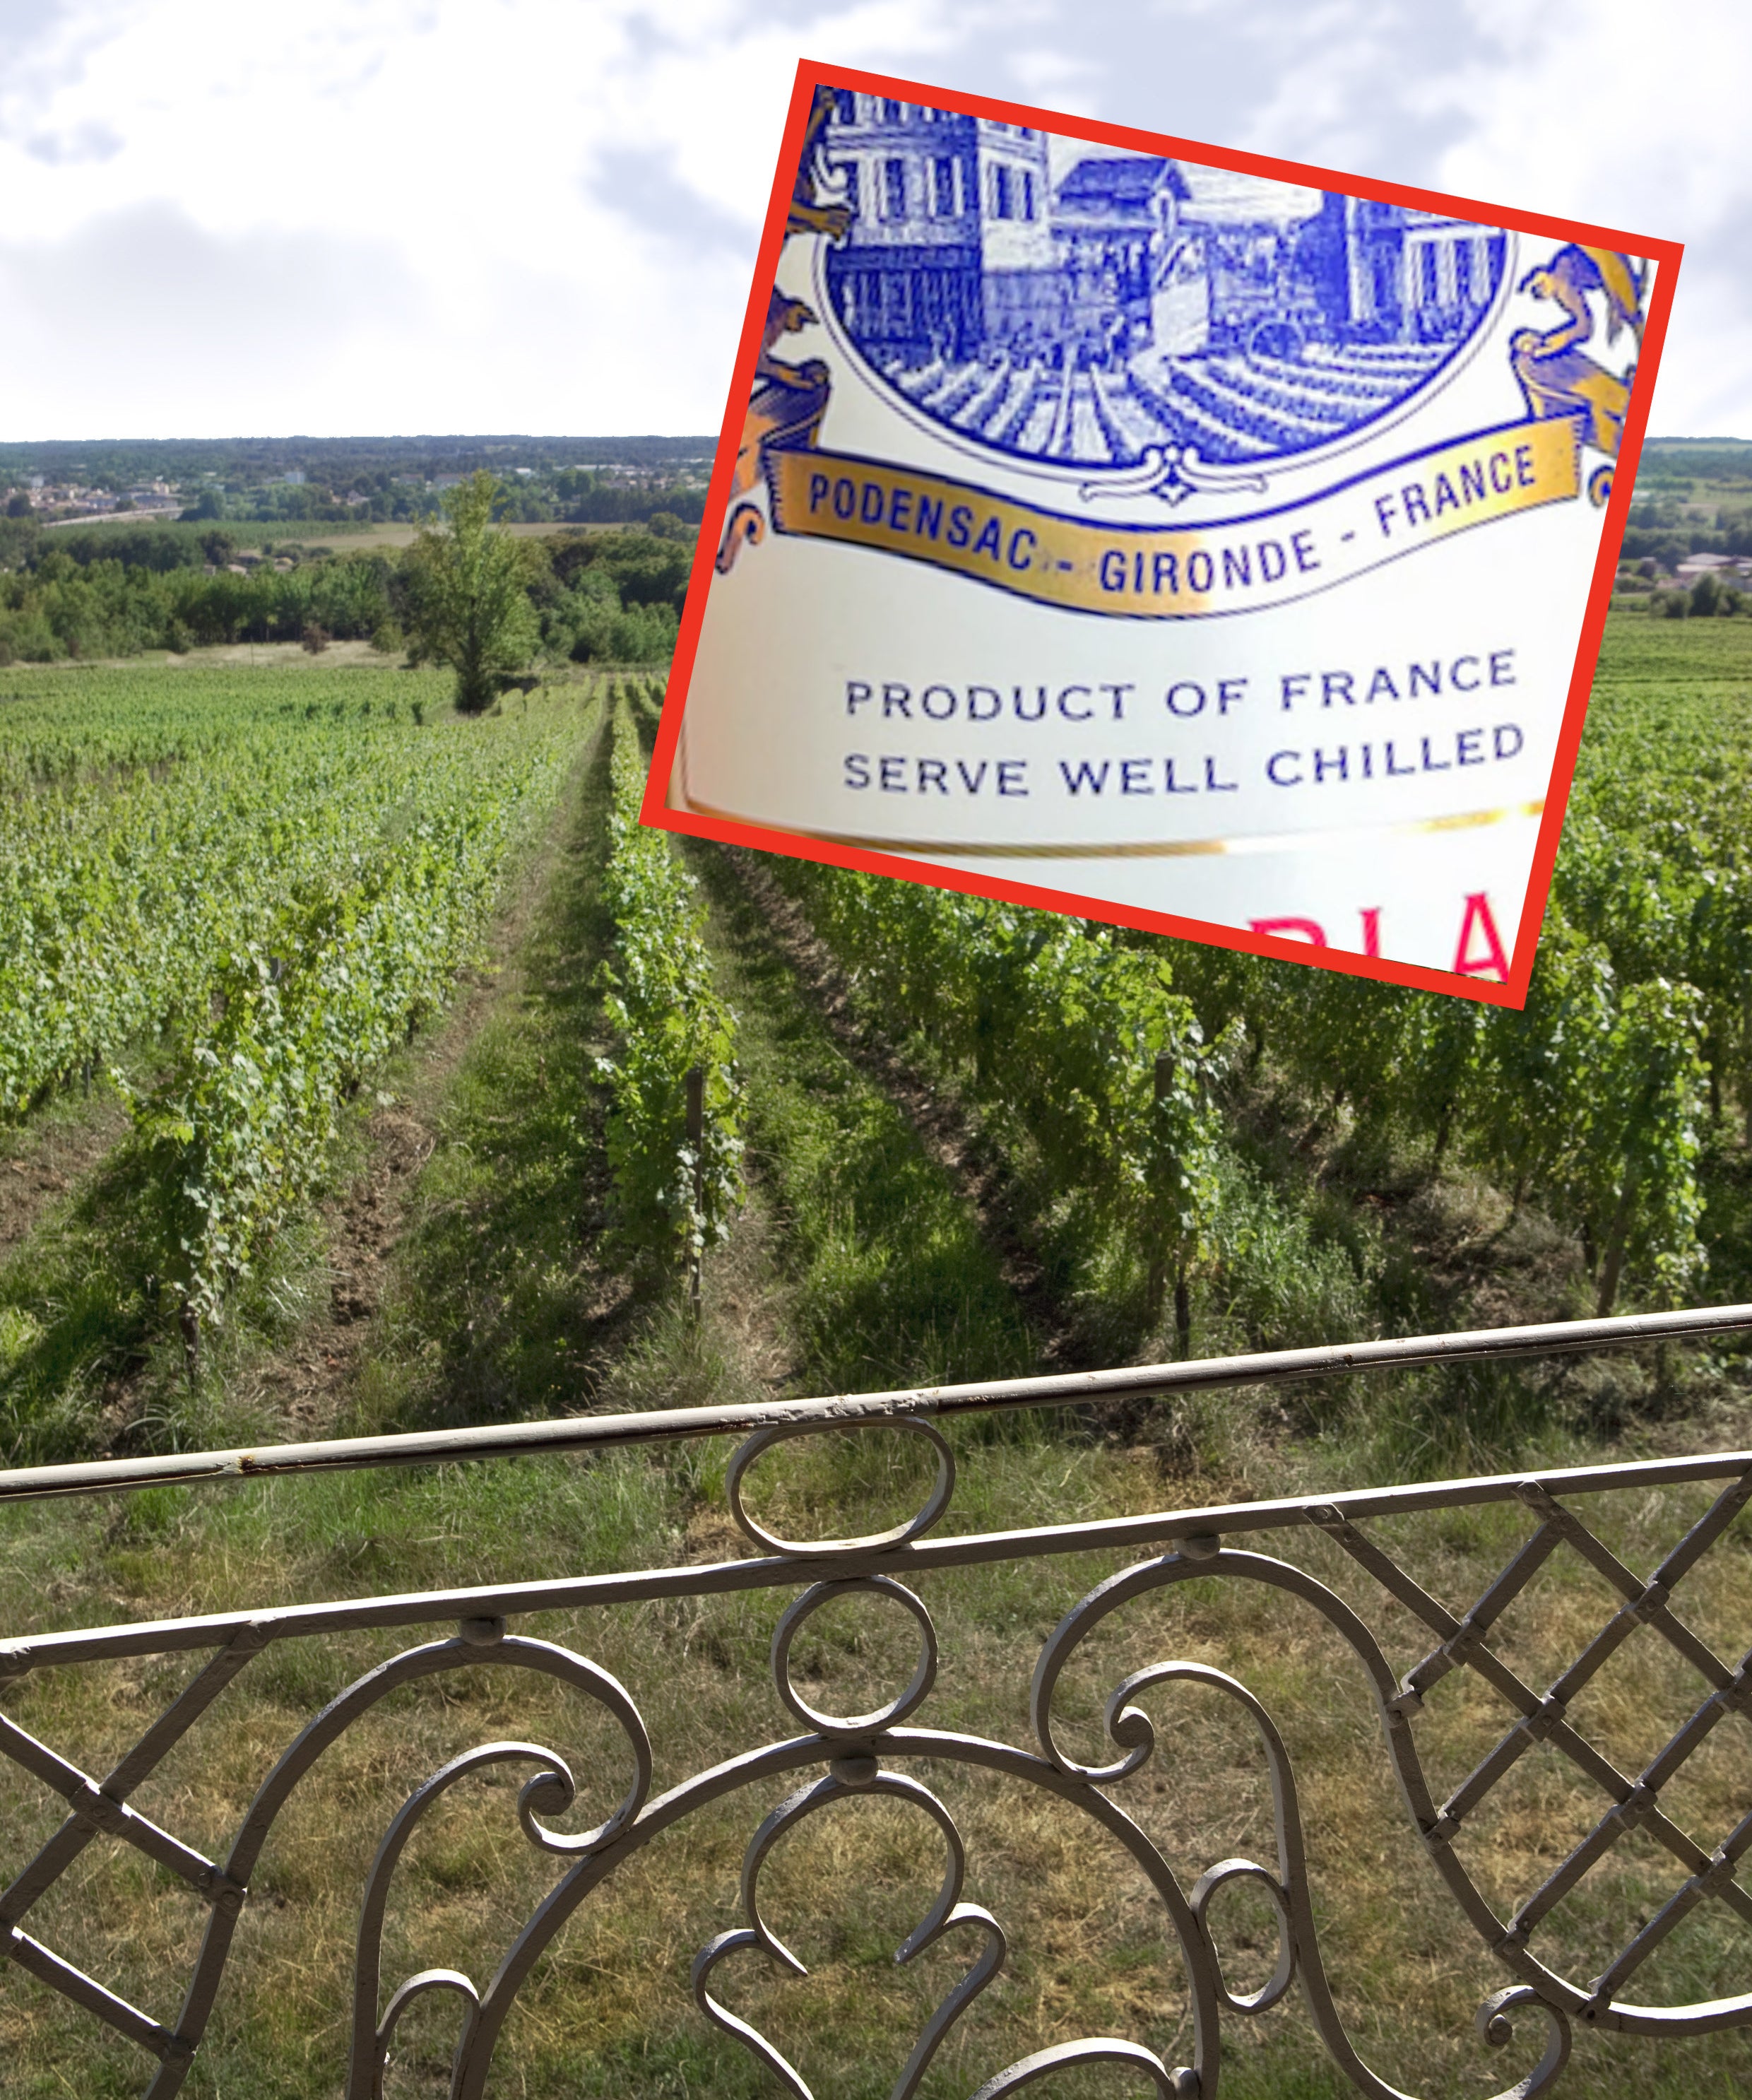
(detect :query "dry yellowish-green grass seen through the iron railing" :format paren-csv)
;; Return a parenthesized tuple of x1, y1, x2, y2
(0, 1441, 1752, 2100)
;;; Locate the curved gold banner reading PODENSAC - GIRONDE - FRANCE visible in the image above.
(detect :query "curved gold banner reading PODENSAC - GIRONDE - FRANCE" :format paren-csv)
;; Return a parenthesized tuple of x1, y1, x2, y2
(764, 415, 1582, 620)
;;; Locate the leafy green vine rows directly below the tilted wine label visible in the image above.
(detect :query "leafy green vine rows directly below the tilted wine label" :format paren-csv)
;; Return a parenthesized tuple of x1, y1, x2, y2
(781, 861, 1708, 1352)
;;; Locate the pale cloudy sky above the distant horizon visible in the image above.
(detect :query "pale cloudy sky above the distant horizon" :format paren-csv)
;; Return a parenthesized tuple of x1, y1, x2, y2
(0, 0, 1752, 439)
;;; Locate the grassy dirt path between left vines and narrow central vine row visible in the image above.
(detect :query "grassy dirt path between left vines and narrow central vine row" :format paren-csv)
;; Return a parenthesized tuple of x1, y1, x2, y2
(246, 706, 790, 1439)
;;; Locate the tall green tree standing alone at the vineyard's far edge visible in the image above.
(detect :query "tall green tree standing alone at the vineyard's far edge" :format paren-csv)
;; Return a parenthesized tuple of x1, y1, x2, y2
(406, 468, 540, 714)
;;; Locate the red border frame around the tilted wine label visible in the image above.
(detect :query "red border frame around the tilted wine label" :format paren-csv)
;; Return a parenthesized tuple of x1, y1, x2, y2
(639, 59, 1685, 1008)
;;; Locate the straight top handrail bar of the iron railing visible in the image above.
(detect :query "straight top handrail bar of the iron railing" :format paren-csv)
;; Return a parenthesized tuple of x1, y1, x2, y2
(0, 1304, 1752, 1502)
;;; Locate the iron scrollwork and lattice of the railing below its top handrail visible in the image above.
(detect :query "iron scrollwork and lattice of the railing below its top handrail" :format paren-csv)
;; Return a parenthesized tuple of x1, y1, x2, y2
(0, 1386, 1752, 2100)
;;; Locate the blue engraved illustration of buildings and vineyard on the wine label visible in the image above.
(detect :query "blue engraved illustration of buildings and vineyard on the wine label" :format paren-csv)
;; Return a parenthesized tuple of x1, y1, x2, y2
(807, 88, 1506, 485)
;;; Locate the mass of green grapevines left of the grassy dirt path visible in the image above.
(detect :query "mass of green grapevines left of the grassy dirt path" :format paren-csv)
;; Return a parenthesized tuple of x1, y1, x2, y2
(0, 672, 576, 1323)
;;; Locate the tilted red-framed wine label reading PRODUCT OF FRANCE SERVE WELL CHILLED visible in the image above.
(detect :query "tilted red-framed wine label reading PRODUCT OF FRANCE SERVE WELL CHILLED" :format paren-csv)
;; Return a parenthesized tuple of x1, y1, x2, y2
(645, 65, 1679, 1004)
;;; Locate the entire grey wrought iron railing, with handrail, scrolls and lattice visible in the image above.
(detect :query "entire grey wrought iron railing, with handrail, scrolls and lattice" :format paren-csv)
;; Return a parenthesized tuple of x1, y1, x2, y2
(0, 1306, 1752, 2100)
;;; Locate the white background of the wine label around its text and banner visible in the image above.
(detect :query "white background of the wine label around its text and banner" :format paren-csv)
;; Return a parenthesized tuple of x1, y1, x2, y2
(678, 217, 1628, 970)
